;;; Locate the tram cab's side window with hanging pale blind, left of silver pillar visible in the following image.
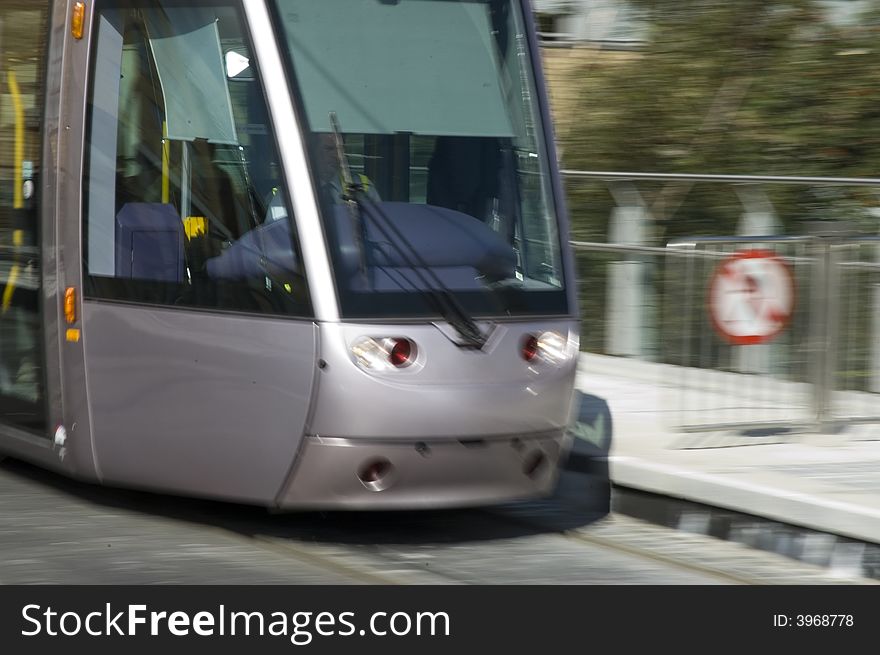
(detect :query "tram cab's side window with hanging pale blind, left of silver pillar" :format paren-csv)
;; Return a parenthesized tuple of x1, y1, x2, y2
(84, 0, 311, 316)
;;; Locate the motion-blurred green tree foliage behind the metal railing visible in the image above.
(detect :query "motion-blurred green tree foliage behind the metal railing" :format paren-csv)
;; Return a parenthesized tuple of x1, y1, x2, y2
(558, 0, 880, 243)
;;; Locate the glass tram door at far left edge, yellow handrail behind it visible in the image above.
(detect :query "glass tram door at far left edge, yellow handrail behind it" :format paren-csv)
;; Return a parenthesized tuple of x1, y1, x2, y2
(0, 0, 48, 434)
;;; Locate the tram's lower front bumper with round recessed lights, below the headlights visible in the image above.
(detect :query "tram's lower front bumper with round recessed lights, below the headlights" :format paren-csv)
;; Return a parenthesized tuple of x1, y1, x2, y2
(278, 431, 570, 509)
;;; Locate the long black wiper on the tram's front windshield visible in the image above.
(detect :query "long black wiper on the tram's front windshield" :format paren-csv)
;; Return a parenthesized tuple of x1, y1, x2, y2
(330, 112, 487, 349)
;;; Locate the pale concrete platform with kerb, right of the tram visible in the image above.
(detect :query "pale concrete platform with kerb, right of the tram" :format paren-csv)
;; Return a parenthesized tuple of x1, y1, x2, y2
(577, 354, 880, 566)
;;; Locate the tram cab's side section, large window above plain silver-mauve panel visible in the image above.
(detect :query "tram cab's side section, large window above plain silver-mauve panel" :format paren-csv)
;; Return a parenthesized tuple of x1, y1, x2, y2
(75, 0, 317, 501)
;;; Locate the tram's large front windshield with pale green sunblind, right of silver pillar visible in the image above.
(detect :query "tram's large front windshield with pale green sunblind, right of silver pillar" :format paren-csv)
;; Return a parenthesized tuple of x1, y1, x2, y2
(274, 0, 567, 318)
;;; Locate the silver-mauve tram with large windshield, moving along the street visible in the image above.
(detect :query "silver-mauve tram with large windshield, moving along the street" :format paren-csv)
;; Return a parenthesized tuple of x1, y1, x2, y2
(0, 0, 579, 509)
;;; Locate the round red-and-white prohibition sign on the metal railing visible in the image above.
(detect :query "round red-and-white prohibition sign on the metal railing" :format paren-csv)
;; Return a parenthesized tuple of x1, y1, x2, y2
(709, 250, 794, 346)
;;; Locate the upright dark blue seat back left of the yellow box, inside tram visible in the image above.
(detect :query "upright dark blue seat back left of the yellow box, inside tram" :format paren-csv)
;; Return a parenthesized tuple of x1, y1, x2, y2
(116, 202, 185, 282)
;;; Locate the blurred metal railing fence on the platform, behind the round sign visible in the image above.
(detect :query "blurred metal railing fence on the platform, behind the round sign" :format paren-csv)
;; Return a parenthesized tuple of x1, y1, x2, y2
(564, 171, 880, 432)
